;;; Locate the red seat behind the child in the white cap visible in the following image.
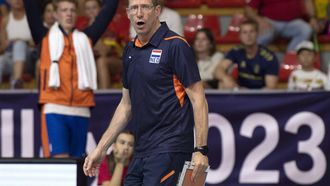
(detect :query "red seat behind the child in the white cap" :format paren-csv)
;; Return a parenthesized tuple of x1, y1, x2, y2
(279, 52, 321, 82)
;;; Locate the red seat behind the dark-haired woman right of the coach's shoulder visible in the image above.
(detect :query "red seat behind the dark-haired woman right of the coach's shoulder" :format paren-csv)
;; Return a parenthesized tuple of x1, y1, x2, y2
(183, 14, 220, 43)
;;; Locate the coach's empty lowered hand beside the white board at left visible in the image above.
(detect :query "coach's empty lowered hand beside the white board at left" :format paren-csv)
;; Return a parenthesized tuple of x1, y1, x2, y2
(83, 148, 106, 177)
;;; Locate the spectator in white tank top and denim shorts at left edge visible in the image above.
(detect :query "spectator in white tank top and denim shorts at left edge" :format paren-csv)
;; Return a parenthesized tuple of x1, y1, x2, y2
(0, 0, 33, 88)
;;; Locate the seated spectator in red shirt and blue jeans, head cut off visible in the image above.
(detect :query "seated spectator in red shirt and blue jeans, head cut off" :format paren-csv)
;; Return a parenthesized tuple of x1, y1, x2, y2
(245, 0, 318, 51)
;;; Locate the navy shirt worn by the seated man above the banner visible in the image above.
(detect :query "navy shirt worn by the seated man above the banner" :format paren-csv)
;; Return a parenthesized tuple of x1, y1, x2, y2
(226, 46, 279, 89)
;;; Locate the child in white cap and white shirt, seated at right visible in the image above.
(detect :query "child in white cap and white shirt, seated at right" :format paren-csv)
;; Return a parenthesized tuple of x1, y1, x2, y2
(288, 41, 329, 91)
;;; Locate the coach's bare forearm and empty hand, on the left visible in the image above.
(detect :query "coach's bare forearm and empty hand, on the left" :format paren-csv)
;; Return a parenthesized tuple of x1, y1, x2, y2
(84, 88, 131, 176)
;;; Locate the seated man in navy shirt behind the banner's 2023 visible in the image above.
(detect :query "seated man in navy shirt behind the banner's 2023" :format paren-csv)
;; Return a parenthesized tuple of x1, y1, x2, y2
(216, 20, 279, 89)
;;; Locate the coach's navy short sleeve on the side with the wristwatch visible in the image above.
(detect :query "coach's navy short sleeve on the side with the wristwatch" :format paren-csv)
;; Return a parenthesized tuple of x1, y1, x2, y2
(170, 38, 201, 87)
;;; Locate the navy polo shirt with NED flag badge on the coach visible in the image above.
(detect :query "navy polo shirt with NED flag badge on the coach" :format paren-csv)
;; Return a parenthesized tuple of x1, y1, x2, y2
(123, 23, 200, 157)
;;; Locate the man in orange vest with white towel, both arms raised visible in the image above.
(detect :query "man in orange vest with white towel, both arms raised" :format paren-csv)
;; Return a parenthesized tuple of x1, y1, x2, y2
(24, 0, 118, 157)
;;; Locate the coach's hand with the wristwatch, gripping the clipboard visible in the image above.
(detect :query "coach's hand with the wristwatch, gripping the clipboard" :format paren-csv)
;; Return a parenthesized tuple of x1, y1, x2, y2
(191, 152, 209, 182)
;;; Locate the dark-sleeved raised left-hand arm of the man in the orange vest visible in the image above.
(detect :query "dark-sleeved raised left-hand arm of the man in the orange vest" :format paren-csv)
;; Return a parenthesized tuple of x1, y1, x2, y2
(24, 0, 48, 45)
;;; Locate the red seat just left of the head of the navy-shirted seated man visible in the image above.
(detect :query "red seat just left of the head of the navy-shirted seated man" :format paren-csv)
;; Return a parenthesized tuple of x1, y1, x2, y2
(218, 14, 246, 44)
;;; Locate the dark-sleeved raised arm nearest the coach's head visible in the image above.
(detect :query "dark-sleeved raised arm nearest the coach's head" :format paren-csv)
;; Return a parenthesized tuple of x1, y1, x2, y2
(84, 0, 118, 45)
